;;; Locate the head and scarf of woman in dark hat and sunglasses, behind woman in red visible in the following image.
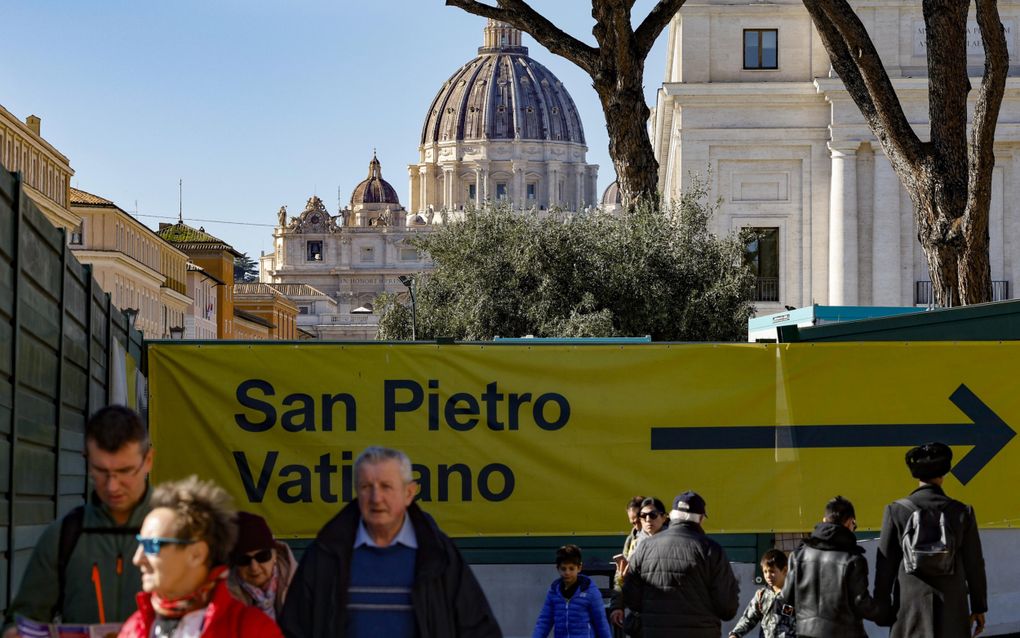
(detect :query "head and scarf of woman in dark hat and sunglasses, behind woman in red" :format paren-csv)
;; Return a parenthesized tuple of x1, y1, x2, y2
(226, 511, 297, 620)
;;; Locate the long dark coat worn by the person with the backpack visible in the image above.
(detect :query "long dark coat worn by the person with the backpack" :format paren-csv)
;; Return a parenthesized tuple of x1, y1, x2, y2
(875, 485, 988, 638)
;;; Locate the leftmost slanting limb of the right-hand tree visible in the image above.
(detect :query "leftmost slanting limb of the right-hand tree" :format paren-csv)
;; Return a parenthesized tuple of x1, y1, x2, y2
(804, 0, 924, 167)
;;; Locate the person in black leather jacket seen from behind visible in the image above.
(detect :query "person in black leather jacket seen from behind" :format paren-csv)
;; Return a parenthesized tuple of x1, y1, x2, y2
(782, 496, 888, 638)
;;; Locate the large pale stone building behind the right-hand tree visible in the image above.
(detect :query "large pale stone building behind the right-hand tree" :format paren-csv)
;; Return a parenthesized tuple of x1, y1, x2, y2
(653, 0, 1020, 313)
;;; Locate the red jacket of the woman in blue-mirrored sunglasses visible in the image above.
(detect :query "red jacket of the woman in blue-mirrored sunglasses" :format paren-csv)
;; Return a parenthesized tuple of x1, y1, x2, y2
(117, 580, 284, 638)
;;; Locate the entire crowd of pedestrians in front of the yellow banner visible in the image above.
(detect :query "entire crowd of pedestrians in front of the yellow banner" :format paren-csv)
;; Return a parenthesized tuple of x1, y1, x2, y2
(2, 406, 987, 638)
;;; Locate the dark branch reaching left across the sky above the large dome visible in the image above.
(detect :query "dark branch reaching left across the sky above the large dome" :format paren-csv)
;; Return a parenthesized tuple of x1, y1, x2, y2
(446, 0, 599, 76)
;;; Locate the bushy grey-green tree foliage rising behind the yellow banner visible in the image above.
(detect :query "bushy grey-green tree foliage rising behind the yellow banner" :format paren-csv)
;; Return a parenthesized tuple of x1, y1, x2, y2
(380, 180, 755, 341)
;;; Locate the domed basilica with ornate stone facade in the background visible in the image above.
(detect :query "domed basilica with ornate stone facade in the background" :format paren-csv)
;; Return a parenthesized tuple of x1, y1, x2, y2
(260, 20, 598, 339)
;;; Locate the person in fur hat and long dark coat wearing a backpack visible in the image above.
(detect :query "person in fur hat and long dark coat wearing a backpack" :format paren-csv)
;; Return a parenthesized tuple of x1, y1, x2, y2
(875, 443, 988, 638)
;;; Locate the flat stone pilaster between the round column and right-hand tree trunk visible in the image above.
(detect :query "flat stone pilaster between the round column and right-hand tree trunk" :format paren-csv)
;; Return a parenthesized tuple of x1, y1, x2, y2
(871, 150, 904, 305)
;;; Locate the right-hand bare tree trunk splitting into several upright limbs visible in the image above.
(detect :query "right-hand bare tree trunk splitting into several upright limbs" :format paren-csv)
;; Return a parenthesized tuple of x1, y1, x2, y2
(804, 0, 1009, 306)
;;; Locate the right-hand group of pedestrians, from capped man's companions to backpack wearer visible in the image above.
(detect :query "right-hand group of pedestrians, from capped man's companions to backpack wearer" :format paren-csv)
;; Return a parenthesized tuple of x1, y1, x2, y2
(599, 443, 987, 638)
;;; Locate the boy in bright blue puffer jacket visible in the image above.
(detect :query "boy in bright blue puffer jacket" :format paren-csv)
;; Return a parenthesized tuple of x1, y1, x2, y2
(531, 545, 612, 638)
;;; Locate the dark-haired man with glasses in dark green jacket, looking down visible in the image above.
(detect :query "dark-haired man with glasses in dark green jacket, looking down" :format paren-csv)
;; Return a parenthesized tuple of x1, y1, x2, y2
(3, 405, 153, 638)
